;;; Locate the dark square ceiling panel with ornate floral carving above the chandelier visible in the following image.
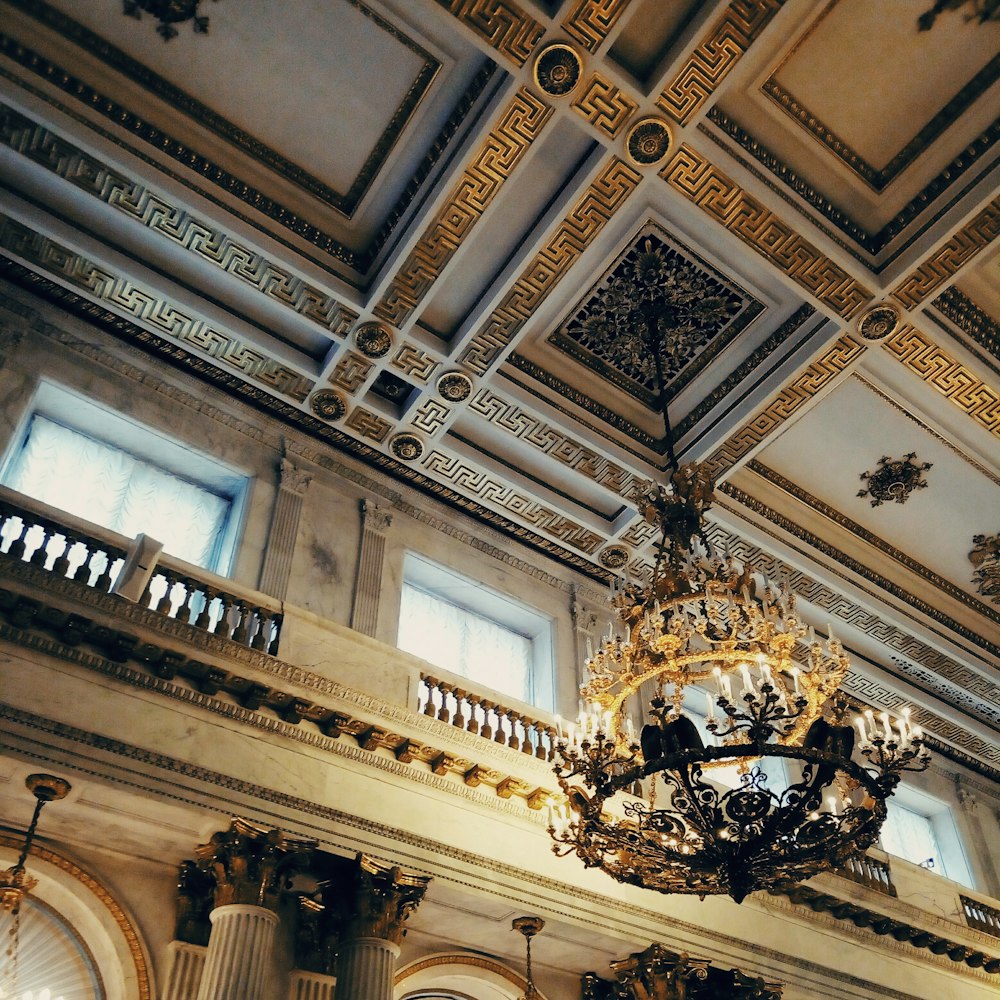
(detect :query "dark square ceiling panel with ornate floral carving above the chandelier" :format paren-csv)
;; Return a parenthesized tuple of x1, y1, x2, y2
(549, 223, 764, 409)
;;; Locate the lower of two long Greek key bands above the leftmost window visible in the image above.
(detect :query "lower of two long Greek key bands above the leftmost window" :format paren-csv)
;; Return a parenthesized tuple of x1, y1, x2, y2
(0, 215, 314, 402)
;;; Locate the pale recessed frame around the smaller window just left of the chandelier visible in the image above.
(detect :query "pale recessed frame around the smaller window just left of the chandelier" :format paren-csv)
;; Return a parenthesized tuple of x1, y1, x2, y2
(396, 552, 555, 712)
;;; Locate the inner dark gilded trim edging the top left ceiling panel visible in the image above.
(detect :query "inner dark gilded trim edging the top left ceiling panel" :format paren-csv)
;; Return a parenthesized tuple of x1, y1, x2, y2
(10, 0, 441, 217)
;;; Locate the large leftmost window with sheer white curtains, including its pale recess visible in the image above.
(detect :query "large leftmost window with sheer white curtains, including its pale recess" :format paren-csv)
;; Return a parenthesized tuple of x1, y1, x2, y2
(0, 383, 247, 574)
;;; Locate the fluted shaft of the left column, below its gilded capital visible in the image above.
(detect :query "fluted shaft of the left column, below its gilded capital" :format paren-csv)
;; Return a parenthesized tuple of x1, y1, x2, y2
(198, 903, 278, 1000)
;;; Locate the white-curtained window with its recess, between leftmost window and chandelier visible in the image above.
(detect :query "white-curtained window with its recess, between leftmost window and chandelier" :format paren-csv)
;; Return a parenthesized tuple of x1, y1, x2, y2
(397, 554, 552, 708)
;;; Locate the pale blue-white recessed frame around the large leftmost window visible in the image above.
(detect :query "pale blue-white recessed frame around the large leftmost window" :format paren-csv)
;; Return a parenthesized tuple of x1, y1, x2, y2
(0, 379, 252, 577)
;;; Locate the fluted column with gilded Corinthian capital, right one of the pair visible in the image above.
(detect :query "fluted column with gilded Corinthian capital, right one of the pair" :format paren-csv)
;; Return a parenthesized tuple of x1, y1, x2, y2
(337, 854, 430, 1000)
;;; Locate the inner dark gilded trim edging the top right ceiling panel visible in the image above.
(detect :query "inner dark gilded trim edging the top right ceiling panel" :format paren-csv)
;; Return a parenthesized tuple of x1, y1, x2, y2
(761, 55, 1000, 193)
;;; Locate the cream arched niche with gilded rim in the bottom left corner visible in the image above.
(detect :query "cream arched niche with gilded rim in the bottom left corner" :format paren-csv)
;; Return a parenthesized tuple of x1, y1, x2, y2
(0, 833, 155, 1000)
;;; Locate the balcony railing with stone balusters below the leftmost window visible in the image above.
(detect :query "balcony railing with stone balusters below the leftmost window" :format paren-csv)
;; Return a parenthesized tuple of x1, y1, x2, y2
(0, 487, 281, 655)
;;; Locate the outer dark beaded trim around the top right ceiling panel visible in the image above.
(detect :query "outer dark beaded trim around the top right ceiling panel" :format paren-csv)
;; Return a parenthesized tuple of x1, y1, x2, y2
(698, 106, 1000, 260)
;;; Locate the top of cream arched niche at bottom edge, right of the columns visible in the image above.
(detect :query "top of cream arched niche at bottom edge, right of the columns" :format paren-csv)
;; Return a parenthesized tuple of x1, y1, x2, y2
(393, 952, 545, 1000)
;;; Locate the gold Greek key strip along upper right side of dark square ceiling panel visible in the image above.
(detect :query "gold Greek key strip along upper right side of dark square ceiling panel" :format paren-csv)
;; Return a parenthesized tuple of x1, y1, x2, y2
(660, 145, 874, 319)
